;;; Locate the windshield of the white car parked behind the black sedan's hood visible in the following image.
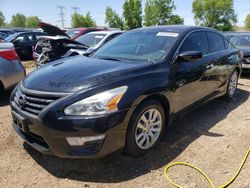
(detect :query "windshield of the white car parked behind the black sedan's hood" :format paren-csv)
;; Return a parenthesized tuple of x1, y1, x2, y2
(76, 33, 106, 47)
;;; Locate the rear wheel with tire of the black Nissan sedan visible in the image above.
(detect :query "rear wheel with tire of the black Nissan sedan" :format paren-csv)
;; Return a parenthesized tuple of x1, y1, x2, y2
(225, 70, 239, 99)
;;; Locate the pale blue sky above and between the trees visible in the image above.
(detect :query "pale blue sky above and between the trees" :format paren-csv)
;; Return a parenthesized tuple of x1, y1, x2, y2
(0, 0, 250, 27)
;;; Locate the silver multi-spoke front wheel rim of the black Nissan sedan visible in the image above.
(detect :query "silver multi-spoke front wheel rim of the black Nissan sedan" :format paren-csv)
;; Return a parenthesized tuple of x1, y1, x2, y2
(135, 109, 162, 150)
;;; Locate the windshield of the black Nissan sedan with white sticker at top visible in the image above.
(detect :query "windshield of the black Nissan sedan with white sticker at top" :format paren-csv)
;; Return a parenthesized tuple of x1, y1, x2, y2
(92, 31, 179, 62)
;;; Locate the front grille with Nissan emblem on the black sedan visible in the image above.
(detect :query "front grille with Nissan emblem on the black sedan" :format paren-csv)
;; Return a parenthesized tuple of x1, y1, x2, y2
(14, 87, 60, 115)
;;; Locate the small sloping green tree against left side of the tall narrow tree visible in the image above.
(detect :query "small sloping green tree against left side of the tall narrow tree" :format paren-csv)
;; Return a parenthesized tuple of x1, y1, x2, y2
(105, 6, 124, 29)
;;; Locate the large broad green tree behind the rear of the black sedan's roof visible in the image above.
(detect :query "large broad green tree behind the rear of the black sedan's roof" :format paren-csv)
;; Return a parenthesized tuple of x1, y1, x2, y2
(193, 0, 237, 31)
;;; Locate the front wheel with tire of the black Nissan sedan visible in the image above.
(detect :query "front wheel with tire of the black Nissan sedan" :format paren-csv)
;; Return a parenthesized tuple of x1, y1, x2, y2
(125, 100, 166, 157)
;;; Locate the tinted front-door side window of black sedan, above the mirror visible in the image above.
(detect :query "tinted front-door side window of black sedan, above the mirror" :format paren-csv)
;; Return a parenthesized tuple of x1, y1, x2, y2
(179, 31, 209, 55)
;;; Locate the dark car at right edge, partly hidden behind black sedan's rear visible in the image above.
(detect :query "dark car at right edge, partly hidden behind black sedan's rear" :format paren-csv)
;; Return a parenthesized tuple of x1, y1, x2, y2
(231, 33, 250, 71)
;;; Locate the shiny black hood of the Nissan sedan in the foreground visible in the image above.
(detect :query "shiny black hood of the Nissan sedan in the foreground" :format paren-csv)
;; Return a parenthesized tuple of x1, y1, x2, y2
(22, 56, 150, 93)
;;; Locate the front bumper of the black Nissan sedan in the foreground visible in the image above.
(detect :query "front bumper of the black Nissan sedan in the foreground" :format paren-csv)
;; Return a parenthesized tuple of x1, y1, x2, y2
(11, 101, 128, 158)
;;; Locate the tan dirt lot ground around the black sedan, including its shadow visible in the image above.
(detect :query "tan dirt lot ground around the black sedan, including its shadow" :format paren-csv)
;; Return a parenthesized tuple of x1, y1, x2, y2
(0, 68, 250, 188)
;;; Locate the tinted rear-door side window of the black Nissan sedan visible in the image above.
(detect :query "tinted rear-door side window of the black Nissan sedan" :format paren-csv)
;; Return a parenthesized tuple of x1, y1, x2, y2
(207, 32, 226, 53)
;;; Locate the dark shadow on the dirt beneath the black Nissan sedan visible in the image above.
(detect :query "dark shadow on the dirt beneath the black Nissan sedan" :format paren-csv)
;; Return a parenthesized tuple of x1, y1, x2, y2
(25, 89, 250, 183)
